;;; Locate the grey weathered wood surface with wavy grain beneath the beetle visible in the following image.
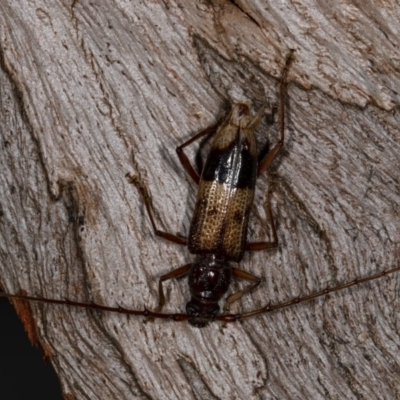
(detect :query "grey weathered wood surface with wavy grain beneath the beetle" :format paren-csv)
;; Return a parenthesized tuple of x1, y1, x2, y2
(0, 0, 400, 399)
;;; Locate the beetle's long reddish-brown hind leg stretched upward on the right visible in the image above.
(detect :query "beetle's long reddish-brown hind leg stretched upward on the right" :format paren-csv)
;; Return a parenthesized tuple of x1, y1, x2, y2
(257, 50, 294, 176)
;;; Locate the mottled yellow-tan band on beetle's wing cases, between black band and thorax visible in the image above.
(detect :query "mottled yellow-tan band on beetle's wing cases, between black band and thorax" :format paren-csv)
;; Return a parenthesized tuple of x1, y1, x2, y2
(189, 180, 254, 261)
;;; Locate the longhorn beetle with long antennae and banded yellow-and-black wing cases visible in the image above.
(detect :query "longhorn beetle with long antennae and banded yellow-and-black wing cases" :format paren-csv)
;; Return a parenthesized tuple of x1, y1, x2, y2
(0, 51, 400, 327)
